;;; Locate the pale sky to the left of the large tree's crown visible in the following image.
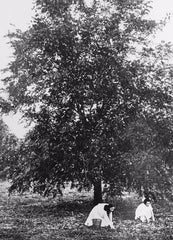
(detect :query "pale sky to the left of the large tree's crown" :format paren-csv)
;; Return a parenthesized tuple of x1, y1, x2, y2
(0, 0, 33, 138)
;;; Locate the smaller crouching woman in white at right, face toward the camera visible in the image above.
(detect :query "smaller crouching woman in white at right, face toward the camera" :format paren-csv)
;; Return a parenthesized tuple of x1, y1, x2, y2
(135, 198, 155, 223)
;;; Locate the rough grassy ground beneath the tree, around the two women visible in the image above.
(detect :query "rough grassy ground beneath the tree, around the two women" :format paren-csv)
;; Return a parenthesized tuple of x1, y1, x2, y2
(0, 182, 173, 240)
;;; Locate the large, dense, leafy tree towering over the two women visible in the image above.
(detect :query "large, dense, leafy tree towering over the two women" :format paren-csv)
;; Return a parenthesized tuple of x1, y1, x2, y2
(3, 0, 172, 202)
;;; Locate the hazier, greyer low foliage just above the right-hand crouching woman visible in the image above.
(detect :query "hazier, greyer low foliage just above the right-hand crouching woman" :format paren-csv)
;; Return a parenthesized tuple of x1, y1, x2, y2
(124, 119, 173, 200)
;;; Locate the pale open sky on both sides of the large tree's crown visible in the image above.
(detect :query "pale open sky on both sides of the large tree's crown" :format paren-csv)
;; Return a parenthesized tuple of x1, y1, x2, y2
(0, 0, 173, 138)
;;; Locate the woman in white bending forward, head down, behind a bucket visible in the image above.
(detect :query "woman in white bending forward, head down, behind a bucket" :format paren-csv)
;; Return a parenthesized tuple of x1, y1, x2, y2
(85, 203, 115, 229)
